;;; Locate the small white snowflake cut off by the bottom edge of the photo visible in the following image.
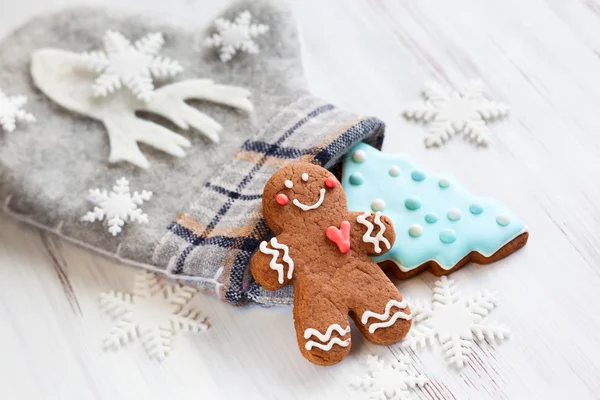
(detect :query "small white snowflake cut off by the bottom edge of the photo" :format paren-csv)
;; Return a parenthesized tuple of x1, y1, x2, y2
(350, 355, 429, 400)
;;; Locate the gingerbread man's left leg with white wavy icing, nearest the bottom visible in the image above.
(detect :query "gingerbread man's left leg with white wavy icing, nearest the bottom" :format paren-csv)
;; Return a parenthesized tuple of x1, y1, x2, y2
(294, 285, 351, 365)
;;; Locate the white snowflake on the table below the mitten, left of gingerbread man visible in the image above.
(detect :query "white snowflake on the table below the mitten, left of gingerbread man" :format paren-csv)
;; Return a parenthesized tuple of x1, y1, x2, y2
(100, 271, 208, 361)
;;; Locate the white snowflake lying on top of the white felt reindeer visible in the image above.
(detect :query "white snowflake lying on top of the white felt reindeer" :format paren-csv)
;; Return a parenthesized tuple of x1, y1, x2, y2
(82, 31, 183, 103)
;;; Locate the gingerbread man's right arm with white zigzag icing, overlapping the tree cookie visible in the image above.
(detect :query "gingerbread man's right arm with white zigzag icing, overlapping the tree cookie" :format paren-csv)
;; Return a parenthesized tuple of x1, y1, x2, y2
(351, 211, 396, 256)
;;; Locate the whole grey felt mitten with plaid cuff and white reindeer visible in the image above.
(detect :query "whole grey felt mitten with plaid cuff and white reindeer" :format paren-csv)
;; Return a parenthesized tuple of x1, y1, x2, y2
(0, 0, 383, 305)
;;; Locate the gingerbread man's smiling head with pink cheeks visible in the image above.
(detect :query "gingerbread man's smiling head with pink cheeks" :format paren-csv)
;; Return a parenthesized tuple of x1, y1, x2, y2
(263, 163, 347, 234)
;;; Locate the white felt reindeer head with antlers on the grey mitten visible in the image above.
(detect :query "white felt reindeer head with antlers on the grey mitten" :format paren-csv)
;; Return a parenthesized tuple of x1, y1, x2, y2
(31, 41, 252, 168)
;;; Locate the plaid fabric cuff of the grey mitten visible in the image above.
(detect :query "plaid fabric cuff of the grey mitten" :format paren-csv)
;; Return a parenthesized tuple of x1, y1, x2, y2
(154, 97, 384, 305)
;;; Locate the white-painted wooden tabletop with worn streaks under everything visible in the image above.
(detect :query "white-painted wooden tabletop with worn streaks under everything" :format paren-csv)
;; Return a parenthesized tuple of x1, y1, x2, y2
(0, 0, 600, 400)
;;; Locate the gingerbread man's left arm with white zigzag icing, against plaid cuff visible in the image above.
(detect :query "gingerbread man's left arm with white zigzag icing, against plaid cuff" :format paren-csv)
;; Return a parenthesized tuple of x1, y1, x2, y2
(250, 236, 294, 290)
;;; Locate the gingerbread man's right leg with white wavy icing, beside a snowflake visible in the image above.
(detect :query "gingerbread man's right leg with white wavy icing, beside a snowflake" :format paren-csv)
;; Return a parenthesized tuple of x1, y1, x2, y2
(349, 271, 412, 344)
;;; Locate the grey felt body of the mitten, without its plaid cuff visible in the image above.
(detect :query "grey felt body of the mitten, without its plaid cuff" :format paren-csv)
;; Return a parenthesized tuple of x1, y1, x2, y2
(0, 0, 384, 304)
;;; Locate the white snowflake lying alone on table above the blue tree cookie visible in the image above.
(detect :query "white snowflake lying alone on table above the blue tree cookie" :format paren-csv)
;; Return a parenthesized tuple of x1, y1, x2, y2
(403, 81, 509, 147)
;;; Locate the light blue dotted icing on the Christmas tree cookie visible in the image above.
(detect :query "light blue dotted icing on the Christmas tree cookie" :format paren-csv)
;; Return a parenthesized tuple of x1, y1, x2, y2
(342, 143, 527, 273)
